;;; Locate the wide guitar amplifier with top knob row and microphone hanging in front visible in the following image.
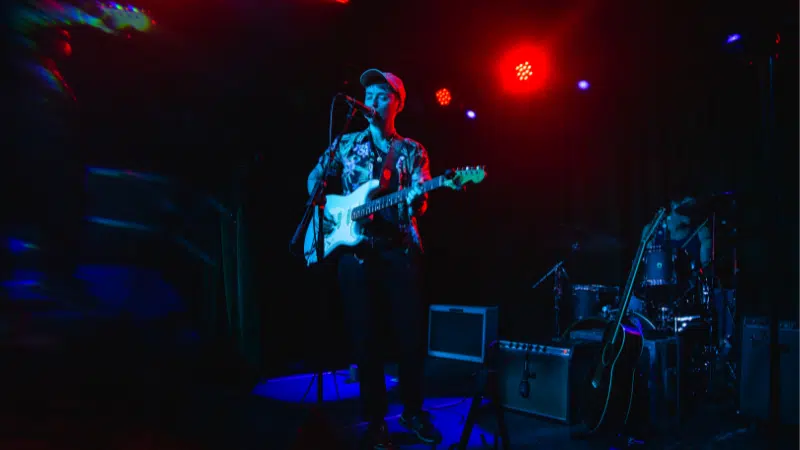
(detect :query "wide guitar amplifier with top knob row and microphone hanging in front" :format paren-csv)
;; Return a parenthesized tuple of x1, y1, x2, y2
(496, 341, 602, 424)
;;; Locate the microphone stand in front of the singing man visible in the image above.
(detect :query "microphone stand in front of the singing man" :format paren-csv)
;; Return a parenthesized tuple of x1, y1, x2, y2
(289, 101, 357, 406)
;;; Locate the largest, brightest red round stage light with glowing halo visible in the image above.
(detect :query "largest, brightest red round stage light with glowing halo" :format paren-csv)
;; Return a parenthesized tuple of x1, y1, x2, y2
(496, 44, 550, 94)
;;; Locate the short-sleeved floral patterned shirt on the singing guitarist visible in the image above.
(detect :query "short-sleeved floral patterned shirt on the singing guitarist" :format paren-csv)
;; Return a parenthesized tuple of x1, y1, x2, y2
(309, 130, 431, 250)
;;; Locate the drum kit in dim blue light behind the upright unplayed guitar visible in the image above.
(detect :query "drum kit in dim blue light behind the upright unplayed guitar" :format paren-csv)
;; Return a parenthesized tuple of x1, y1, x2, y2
(537, 193, 738, 394)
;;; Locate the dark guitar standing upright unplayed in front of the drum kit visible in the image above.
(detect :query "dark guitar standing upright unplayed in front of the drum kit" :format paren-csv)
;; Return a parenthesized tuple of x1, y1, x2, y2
(581, 208, 666, 434)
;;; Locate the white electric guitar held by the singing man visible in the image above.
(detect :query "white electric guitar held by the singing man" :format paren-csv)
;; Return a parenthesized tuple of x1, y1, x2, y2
(303, 166, 486, 266)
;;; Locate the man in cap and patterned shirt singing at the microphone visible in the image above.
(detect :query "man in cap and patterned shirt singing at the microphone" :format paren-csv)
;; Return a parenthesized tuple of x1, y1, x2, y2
(308, 69, 441, 448)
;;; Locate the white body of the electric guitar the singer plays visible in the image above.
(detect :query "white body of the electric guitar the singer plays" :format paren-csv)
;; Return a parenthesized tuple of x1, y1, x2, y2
(303, 180, 380, 265)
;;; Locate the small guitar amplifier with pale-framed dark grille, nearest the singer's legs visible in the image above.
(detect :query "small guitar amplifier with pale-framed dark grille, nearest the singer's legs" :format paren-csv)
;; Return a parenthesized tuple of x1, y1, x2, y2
(428, 305, 498, 364)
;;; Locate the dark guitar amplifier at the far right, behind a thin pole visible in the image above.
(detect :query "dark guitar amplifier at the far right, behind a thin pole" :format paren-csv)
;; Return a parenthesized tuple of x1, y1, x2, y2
(739, 316, 800, 424)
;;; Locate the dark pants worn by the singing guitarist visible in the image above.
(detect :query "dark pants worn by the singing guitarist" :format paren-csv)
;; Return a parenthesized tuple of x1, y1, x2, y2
(339, 244, 426, 421)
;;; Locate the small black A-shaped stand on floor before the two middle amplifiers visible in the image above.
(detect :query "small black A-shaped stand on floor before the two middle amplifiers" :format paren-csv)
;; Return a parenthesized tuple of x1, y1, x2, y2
(449, 341, 511, 450)
